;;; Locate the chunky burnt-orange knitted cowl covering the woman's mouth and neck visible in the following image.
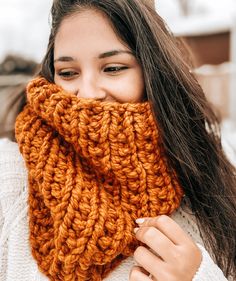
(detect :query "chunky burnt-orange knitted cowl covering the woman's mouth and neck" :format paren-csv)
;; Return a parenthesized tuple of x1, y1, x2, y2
(16, 77, 183, 281)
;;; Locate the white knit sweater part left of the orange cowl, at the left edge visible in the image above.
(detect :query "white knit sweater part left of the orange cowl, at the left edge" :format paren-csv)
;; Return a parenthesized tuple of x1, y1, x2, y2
(0, 139, 48, 281)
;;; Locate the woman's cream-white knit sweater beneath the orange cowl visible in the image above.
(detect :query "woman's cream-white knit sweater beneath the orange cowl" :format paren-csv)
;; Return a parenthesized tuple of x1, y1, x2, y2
(0, 139, 227, 281)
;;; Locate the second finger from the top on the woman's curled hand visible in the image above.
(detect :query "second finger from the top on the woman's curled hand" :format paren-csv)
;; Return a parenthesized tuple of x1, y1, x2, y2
(136, 223, 176, 262)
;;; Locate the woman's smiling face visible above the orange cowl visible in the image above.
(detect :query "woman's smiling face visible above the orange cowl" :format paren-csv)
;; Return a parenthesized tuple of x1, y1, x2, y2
(54, 10, 144, 103)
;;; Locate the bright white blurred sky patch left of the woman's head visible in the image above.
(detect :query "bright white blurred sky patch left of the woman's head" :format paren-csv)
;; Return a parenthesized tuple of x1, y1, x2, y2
(0, 0, 52, 62)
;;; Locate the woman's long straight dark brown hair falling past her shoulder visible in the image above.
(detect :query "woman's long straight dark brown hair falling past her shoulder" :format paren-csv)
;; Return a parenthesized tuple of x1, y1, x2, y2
(14, 0, 236, 277)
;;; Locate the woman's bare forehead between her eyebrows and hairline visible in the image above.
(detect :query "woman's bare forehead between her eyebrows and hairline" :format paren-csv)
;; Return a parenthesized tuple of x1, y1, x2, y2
(54, 10, 128, 55)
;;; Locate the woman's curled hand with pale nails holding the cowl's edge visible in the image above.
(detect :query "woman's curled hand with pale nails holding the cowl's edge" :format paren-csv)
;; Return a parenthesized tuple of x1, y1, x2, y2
(129, 215, 202, 281)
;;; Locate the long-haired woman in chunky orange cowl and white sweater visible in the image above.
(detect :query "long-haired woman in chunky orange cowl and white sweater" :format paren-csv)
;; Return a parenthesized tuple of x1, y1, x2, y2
(1, 0, 236, 281)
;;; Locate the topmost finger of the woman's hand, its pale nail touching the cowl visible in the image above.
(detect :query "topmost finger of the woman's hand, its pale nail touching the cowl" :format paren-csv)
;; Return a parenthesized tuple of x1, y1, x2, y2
(136, 215, 192, 245)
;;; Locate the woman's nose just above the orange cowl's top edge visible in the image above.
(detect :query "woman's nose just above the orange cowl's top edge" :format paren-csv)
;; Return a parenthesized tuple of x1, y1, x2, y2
(76, 76, 107, 100)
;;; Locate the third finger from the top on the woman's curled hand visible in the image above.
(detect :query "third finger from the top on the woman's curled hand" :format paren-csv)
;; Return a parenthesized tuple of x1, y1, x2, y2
(134, 246, 167, 279)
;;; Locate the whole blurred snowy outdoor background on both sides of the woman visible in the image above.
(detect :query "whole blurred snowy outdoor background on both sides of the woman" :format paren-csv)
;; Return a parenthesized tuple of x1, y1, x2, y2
(0, 0, 236, 164)
